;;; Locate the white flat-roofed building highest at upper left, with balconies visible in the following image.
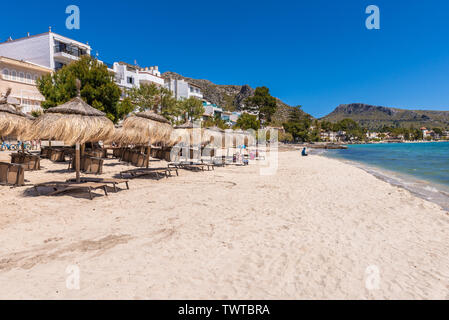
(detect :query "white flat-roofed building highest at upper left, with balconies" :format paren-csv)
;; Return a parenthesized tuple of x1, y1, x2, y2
(0, 29, 91, 70)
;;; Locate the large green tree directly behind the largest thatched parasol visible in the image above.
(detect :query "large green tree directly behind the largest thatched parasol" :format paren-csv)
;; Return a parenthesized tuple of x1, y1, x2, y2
(37, 56, 121, 122)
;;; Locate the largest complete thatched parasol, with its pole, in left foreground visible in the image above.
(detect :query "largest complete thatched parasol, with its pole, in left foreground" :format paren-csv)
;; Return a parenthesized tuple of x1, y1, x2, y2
(32, 80, 114, 183)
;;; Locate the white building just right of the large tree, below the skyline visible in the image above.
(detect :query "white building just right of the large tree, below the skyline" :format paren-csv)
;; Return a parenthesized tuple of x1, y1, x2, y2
(113, 62, 165, 89)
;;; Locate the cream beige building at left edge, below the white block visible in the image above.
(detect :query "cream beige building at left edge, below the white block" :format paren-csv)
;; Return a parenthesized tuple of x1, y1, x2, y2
(0, 57, 52, 114)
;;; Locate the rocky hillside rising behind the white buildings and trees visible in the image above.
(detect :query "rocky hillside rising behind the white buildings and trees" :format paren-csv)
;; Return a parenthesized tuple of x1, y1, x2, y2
(162, 71, 312, 125)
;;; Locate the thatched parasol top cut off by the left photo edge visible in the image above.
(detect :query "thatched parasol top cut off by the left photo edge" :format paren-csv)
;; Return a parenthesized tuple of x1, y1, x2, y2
(0, 88, 31, 139)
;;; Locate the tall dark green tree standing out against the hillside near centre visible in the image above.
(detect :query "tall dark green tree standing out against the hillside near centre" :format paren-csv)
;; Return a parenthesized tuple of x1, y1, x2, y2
(245, 87, 277, 122)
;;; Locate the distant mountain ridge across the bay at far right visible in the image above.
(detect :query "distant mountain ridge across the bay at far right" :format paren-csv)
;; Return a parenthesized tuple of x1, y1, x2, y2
(322, 103, 449, 129)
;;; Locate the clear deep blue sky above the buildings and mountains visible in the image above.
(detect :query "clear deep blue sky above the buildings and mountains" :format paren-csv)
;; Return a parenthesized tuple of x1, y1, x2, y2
(0, 0, 449, 117)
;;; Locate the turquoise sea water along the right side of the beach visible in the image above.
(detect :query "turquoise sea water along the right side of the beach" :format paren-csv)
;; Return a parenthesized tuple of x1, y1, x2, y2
(325, 142, 449, 209)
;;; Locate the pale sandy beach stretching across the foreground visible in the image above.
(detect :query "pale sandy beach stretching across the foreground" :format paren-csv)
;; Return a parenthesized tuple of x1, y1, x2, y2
(0, 151, 449, 299)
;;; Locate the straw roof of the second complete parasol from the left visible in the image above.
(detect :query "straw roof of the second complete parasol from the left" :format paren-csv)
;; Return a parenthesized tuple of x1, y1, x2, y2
(116, 111, 173, 145)
